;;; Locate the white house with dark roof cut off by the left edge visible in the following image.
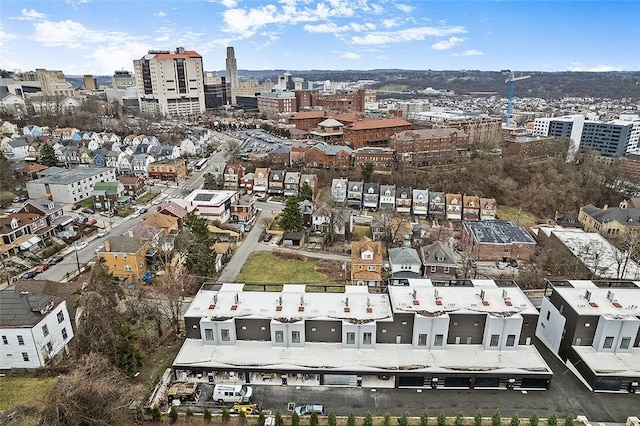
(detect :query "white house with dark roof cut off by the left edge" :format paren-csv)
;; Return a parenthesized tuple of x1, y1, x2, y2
(0, 287, 74, 370)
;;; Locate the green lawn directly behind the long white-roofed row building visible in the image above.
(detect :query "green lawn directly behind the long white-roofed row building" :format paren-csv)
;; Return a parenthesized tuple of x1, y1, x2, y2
(237, 251, 327, 284)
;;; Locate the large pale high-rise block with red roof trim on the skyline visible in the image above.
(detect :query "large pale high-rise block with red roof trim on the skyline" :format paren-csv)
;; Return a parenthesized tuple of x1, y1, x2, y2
(133, 47, 205, 116)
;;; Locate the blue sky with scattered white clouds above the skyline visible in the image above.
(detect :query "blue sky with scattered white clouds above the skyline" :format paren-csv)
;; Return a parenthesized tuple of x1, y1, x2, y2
(0, 0, 640, 75)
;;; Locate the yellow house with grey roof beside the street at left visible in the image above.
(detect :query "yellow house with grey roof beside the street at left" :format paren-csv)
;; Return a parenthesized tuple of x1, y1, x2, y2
(98, 234, 151, 281)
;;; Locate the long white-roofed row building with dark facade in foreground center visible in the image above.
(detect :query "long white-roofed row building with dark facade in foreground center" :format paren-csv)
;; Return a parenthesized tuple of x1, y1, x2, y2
(173, 279, 552, 390)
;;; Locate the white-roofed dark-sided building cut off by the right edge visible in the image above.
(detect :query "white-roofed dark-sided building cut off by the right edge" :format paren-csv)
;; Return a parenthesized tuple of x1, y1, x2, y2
(536, 280, 640, 393)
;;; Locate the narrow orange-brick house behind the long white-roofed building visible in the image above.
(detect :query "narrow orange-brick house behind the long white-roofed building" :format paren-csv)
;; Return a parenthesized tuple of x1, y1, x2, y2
(351, 238, 382, 289)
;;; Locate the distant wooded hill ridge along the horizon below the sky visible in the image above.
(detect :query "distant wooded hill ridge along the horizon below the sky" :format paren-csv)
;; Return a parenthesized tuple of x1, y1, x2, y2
(67, 69, 640, 100)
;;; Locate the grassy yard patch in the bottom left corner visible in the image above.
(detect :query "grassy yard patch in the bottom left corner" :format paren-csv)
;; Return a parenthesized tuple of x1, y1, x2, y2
(0, 377, 56, 411)
